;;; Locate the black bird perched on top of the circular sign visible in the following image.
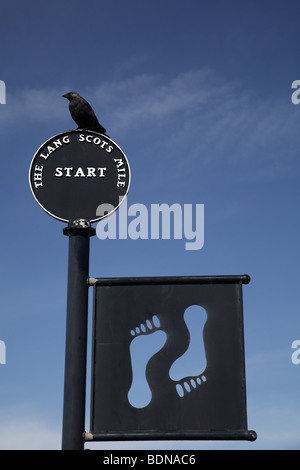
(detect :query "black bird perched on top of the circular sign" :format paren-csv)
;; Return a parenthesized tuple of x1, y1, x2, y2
(62, 91, 106, 134)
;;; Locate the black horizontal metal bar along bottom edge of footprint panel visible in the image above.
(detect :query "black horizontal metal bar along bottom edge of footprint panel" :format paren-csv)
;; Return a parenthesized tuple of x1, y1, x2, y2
(84, 430, 257, 442)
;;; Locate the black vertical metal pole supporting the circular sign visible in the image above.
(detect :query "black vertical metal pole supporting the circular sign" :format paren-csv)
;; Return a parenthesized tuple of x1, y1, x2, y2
(62, 220, 95, 450)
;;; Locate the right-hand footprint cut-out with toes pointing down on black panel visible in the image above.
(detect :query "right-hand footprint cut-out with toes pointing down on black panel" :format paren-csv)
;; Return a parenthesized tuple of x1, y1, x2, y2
(169, 305, 207, 397)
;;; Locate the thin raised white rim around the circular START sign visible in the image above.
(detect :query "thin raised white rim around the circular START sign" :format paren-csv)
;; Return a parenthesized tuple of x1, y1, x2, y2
(28, 129, 131, 223)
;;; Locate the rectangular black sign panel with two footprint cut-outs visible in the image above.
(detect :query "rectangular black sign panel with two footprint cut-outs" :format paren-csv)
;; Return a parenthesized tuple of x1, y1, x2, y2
(86, 275, 256, 441)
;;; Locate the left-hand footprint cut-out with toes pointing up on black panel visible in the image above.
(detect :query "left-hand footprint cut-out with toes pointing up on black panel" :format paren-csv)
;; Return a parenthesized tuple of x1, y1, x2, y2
(128, 315, 167, 408)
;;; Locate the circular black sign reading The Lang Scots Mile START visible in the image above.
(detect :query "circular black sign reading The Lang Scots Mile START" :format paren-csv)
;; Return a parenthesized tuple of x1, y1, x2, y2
(29, 130, 130, 222)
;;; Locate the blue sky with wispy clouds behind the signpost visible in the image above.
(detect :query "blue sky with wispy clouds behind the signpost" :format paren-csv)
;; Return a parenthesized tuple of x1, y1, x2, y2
(0, 0, 300, 449)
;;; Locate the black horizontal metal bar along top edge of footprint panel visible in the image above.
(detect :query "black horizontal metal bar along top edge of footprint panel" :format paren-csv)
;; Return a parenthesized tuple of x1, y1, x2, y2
(89, 274, 251, 286)
